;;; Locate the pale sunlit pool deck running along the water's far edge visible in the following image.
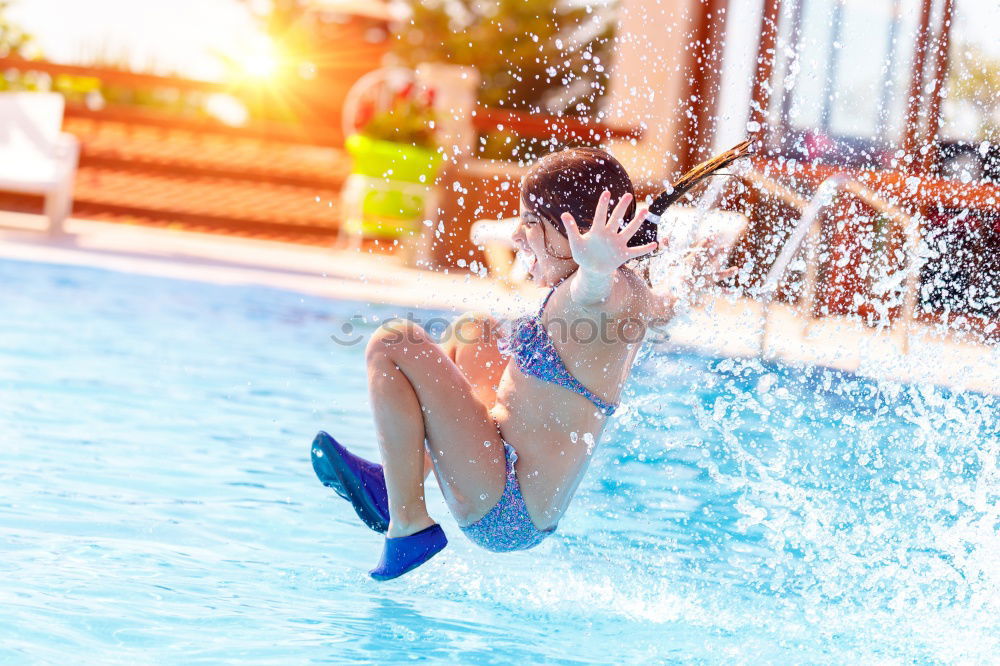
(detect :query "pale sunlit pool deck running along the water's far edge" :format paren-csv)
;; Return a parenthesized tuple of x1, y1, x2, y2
(0, 213, 1000, 395)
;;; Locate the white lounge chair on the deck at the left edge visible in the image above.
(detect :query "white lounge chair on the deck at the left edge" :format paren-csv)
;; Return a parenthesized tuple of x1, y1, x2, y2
(0, 92, 80, 234)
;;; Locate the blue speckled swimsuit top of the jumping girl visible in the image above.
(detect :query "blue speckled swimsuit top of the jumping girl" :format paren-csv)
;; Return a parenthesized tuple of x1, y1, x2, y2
(500, 287, 618, 416)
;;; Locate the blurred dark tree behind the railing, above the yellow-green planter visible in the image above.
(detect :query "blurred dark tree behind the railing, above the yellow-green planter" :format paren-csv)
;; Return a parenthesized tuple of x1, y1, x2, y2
(395, 0, 615, 159)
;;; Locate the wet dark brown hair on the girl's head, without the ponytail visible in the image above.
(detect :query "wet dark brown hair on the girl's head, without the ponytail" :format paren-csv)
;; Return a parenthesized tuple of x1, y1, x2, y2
(521, 148, 657, 247)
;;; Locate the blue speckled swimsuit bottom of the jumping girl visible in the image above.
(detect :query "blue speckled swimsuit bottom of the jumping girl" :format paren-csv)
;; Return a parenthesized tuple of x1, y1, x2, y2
(462, 442, 556, 553)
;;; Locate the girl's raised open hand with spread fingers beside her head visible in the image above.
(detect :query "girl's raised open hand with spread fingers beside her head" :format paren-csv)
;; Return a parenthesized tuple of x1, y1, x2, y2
(562, 190, 658, 274)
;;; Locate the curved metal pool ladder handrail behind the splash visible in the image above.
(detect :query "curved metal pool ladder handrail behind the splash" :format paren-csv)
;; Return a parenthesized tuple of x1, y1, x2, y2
(741, 170, 922, 356)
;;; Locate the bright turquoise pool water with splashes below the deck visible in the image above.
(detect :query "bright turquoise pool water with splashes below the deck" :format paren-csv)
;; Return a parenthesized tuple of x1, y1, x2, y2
(0, 261, 1000, 663)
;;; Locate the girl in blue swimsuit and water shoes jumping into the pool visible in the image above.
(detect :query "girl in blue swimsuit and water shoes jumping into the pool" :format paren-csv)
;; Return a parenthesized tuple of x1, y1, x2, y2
(312, 148, 745, 580)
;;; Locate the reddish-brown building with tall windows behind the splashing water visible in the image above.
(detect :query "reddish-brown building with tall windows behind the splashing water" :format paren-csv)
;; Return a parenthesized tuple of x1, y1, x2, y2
(610, 0, 1000, 328)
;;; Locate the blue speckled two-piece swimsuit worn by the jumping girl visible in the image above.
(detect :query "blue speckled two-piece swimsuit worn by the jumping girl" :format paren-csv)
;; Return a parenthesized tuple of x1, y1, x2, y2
(462, 287, 616, 552)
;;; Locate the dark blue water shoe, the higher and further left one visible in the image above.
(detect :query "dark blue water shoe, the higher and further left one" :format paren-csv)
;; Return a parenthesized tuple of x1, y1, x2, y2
(312, 430, 390, 536)
